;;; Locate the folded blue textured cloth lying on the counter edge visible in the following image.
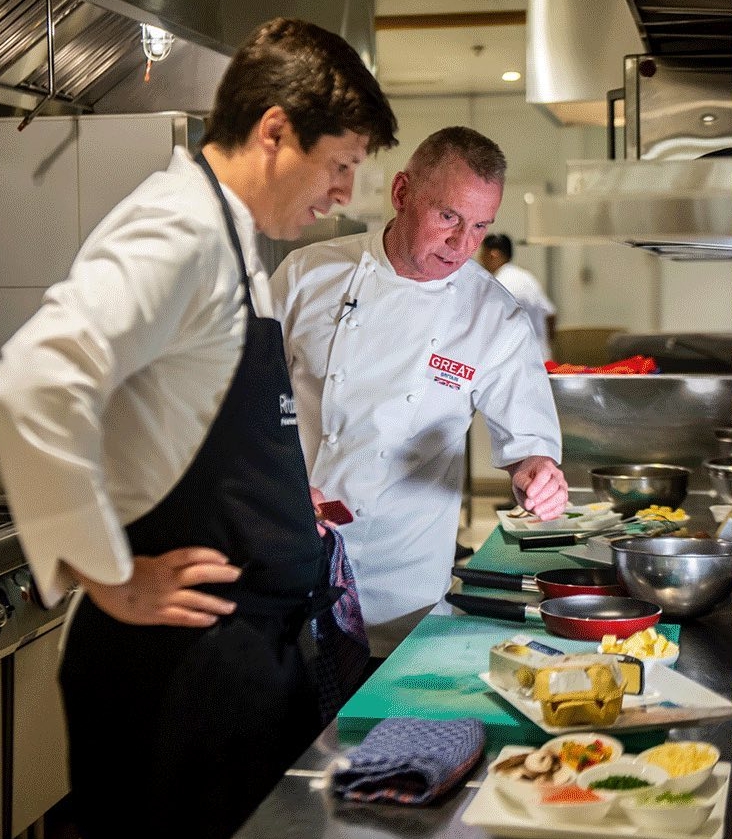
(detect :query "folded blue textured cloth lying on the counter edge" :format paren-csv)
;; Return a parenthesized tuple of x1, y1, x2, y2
(332, 717, 485, 804)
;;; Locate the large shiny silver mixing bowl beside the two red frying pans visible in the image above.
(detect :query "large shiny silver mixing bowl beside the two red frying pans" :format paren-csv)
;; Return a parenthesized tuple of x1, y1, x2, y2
(611, 536, 732, 618)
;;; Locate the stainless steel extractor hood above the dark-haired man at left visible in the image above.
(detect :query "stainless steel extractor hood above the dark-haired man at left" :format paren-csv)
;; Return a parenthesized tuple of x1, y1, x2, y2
(0, 0, 376, 123)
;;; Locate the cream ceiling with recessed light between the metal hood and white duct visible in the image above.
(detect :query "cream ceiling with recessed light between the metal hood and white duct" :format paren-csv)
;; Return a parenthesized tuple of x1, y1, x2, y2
(376, 0, 527, 96)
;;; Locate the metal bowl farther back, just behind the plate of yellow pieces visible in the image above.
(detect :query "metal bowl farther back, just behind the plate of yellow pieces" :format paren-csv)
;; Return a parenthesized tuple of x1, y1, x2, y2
(590, 463, 691, 516)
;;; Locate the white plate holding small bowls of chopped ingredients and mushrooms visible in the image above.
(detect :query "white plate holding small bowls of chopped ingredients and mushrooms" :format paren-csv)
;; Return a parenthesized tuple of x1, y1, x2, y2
(462, 746, 730, 839)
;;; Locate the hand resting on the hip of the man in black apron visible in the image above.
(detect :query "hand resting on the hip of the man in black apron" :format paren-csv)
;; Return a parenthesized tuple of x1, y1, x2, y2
(72, 547, 241, 629)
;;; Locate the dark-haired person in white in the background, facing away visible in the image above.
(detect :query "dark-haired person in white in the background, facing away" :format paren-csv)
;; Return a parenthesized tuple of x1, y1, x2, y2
(478, 233, 557, 361)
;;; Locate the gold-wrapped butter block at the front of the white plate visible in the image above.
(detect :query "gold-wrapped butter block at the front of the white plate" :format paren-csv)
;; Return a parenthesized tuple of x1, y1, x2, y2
(534, 654, 626, 727)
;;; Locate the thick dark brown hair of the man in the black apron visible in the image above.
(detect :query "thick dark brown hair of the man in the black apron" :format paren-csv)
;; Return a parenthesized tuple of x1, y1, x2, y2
(203, 18, 397, 153)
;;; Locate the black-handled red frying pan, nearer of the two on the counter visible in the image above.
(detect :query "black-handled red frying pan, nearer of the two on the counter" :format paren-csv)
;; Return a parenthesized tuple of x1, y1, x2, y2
(445, 593, 661, 641)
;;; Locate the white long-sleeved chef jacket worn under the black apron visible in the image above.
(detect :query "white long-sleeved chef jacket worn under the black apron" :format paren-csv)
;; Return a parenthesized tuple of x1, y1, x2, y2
(0, 148, 271, 605)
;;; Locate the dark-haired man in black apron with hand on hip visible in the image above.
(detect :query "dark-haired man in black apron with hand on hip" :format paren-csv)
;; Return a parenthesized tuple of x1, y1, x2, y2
(0, 19, 396, 839)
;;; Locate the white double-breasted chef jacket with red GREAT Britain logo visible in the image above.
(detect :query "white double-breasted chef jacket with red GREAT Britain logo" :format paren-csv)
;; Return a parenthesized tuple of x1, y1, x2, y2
(270, 230, 561, 655)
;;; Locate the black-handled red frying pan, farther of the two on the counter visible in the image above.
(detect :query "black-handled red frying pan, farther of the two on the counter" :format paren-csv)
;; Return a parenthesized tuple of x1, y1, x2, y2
(452, 568, 627, 597)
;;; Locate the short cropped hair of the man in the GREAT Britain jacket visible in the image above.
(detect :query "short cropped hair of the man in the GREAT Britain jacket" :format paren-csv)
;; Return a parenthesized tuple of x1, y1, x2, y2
(407, 125, 506, 184)
